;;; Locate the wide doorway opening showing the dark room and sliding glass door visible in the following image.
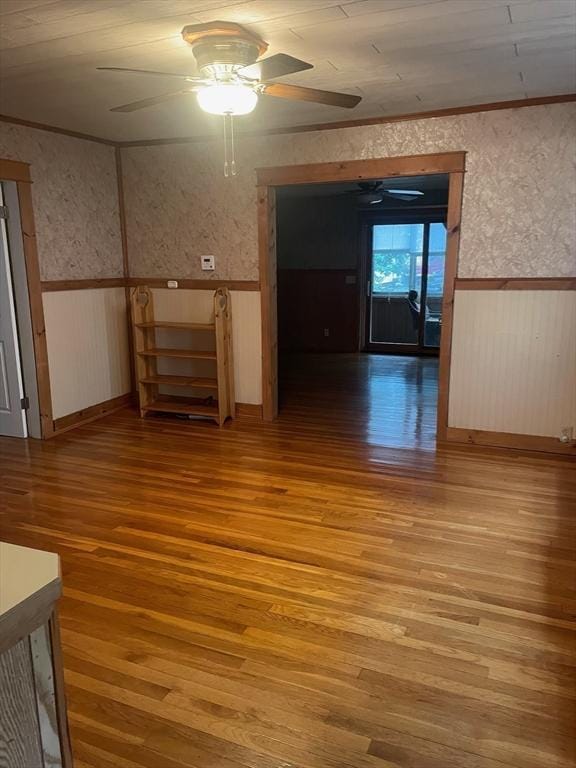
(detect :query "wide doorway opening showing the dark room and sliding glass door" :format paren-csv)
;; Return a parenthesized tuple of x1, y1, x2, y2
(276, 174, 449, 449)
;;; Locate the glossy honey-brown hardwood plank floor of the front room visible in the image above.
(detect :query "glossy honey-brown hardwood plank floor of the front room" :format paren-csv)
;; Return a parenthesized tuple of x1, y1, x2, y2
(0, 354, 576, 768)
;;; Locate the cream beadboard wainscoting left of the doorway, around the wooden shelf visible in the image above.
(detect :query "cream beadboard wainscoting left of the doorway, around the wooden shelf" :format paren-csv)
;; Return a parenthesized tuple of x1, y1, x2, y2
(42, 281, 262, 432)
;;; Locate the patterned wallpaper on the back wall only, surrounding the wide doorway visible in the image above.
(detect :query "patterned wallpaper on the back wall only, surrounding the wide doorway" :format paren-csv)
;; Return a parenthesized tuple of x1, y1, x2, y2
(123, 103, 576, 280)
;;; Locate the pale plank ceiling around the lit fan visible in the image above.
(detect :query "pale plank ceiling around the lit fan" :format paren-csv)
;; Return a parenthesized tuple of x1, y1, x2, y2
(0, 0, 576, 140)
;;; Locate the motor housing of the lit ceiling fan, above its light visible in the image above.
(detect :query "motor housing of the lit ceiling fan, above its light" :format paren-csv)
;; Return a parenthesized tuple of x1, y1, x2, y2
(182, 21, 268, 81)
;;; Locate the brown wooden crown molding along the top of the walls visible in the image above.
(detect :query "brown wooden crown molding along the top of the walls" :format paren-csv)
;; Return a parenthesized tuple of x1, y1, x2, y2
(0, 93, 576, 149)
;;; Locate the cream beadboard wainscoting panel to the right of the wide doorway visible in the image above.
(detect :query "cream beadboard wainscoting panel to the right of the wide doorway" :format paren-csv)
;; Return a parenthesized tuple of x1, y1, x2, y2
(448, 290, 576, 448)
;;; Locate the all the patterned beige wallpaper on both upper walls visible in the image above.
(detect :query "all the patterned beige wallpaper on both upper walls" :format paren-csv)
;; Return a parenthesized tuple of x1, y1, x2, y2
(0, 103, 576, 280)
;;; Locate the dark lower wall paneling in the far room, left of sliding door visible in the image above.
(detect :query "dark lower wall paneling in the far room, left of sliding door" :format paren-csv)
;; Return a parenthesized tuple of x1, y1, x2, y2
(278, 269, 359, 352)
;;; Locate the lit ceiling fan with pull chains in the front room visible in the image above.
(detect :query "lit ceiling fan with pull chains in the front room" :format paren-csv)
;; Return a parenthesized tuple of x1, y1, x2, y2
(98, 21, 361, 116)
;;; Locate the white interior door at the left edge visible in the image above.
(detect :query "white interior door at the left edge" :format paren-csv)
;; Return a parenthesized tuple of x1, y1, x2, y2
(0, 185, 28, 437)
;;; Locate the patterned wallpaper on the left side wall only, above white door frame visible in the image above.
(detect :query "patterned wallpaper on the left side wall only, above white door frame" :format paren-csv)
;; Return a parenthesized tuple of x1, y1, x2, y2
(0, 122, 123, 280)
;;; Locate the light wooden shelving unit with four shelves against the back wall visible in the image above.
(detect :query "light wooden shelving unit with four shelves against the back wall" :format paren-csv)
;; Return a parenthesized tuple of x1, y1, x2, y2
(131, 286, 235, 426)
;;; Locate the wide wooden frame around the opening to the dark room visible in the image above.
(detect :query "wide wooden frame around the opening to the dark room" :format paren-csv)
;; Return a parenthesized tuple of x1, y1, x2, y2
(256, 151, 466, 441)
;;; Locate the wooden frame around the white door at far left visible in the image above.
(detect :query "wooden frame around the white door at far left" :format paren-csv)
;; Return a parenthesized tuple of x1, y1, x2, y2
(0, 159, 54, 439)
